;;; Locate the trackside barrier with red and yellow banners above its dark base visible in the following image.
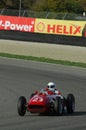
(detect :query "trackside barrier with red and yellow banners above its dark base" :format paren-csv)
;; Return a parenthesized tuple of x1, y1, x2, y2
(0, 16, 86, 46)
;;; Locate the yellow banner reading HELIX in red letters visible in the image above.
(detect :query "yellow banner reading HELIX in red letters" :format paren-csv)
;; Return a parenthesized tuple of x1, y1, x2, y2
(35, 19, 86, 37)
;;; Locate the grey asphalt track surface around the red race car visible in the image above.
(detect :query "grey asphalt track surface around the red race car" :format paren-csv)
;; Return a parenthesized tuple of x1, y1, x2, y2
(0, 58, 86, 130)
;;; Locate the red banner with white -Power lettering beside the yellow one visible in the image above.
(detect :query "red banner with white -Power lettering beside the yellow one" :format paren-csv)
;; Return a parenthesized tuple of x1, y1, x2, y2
(0, 16, 35, 32)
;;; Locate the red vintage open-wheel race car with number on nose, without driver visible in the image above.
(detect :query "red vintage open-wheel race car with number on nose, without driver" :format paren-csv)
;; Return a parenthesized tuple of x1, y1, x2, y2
(17, 91, 75, 116)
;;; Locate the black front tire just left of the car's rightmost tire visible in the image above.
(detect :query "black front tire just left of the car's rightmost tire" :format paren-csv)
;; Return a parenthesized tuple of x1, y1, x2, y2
(54, 97, 63, 116)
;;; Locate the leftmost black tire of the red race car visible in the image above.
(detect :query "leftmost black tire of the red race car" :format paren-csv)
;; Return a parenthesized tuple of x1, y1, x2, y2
(17, 96, 27, 116)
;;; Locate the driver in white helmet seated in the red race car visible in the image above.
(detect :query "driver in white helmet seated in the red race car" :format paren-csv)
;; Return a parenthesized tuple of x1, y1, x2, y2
(45, 82, 61, 95)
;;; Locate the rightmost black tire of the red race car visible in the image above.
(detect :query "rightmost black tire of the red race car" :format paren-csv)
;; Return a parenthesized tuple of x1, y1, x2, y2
(66, 94, 75, 113)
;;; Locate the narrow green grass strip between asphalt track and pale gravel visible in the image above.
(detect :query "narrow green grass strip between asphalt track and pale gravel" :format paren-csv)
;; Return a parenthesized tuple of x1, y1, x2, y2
(0, 53, 86, 68)
